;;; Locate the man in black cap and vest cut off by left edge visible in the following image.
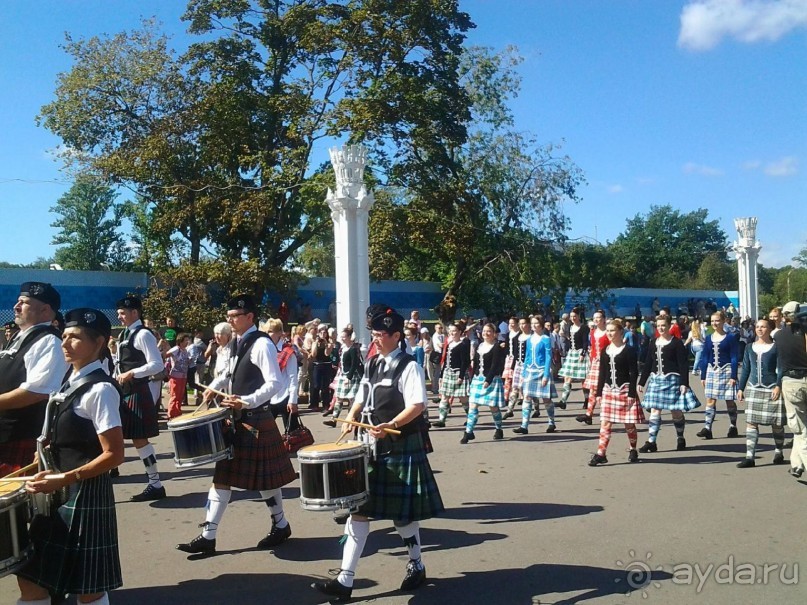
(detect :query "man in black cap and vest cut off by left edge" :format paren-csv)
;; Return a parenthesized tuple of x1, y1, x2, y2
(0, 282, 68, 477)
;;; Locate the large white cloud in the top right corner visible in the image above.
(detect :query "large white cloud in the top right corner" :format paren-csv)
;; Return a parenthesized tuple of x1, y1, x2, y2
(678, 0, 807, 51)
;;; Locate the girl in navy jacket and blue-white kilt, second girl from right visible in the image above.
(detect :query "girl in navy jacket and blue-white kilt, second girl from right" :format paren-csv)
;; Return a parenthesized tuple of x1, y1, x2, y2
(698, 311, 740, 439)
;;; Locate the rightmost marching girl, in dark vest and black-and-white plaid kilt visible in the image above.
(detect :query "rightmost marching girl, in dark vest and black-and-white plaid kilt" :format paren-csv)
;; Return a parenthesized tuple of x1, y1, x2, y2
(737, 319, 787, 468)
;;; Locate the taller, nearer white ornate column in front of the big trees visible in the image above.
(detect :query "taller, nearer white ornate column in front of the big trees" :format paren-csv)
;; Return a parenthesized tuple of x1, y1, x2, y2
(325, 145, 375, 345)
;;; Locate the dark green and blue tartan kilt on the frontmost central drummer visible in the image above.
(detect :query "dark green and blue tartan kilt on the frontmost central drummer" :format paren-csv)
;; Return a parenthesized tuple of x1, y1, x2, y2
(358, 432, 445, 525)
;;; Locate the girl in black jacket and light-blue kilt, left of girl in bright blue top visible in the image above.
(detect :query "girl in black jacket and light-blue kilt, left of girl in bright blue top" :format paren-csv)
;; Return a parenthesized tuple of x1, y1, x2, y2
(460, 323, 505, 444)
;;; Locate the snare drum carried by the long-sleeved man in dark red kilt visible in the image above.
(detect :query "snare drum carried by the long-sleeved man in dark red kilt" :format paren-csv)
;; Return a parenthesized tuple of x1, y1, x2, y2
(168, 408, 233, 468)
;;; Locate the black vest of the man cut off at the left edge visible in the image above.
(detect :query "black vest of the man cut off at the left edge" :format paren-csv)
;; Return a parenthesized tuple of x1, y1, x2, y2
(0, 325, 60, 443)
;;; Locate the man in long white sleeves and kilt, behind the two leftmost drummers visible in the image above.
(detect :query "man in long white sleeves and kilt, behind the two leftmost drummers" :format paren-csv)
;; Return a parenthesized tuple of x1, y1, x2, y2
(115, 296, 165, 502)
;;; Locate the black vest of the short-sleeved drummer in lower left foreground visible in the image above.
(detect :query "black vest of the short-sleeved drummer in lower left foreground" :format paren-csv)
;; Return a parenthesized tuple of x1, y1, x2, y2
(48, 368, 120, 473)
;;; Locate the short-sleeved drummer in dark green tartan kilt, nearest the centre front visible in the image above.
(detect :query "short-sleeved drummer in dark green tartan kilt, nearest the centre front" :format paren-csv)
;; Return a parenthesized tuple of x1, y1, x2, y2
(312, 308, 445, 602)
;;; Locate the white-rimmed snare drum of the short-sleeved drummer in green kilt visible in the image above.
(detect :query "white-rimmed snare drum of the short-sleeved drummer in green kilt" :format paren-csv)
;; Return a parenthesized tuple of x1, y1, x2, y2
(297, 441, 369, 511)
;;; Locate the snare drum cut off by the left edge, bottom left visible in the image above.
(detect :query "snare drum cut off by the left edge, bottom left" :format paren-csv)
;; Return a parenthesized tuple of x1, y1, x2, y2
(0, 481, 34, 578)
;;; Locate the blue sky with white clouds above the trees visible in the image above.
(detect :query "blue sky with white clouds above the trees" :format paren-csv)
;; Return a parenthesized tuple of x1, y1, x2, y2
(0, 0, 807, 266)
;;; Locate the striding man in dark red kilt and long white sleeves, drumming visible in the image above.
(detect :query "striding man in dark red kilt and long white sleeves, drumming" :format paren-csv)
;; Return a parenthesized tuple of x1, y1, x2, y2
(177, 295, 297, 554)
